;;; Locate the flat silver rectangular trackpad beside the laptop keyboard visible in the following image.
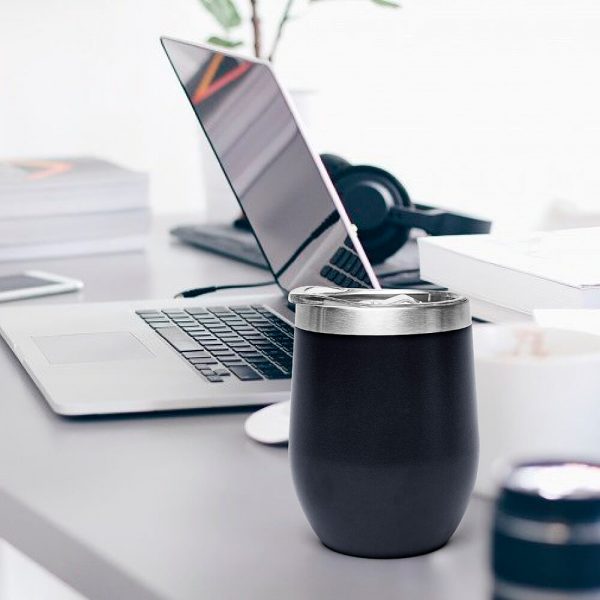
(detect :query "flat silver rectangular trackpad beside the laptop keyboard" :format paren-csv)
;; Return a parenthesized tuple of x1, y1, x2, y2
(32, 331, 154, 365)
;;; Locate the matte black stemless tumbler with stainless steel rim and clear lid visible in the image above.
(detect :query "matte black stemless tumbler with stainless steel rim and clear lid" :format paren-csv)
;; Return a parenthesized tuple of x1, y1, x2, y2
(289, 286, 478, 558)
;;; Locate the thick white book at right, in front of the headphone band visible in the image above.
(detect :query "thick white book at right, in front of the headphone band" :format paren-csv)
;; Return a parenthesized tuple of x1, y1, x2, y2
(418, 227, 600, 320)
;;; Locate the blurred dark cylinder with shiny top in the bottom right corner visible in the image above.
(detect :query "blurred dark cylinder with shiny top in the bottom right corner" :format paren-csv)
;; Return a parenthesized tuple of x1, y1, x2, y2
(492, 462, 600, 600)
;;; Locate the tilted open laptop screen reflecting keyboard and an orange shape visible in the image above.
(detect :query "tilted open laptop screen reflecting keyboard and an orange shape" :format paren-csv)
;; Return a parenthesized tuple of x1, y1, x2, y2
(162, 38, 377, 291)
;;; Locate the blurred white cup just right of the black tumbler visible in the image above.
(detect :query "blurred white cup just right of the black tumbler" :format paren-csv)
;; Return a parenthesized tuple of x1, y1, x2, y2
(473, 325, 600, 495)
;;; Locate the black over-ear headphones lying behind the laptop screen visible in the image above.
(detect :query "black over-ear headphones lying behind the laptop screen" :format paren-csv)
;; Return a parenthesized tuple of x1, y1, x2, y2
(321, 154, 491, 264)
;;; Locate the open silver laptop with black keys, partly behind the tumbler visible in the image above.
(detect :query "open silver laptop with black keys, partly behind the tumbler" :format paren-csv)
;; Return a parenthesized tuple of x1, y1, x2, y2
(0, 39, 378, 415)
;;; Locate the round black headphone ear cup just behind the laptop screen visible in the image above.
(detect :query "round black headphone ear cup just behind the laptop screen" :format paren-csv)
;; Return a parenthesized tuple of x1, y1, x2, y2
(334, 165, 412, 264)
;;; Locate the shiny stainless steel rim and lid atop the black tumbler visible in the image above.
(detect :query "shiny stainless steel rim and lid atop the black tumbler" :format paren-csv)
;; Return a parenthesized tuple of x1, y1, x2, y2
(289, 286, 471, 335)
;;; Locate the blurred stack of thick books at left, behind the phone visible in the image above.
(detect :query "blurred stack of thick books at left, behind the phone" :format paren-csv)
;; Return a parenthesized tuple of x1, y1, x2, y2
(0, 157, 150, 260)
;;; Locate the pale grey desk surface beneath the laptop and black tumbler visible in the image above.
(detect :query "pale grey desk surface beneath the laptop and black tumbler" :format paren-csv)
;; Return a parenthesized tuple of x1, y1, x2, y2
(0, 218, 490, 600)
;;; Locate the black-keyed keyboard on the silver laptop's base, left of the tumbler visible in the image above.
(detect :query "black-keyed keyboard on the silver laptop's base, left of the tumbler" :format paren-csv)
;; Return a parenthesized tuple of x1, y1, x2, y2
(136, 306, 294, 383)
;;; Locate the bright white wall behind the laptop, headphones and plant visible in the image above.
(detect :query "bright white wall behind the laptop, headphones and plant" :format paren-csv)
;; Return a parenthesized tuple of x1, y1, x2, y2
(0, 0, 600, 228)
